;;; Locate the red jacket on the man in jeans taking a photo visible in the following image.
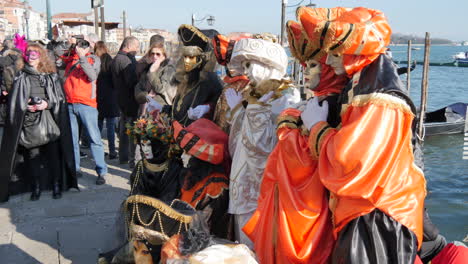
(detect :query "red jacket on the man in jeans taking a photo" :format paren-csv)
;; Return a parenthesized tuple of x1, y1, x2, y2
(64, 54, 101, 108)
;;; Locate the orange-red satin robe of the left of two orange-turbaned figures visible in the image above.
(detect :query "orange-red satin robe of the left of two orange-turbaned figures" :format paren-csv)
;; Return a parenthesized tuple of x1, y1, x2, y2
(243, 109, 334, 264)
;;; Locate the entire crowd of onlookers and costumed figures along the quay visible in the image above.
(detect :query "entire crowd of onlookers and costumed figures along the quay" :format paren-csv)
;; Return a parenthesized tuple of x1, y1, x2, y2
(0, 4, 468, 264)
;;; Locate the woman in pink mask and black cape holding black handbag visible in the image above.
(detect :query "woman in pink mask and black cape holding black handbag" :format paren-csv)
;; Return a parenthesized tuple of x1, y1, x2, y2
(0, 44, 78, 202)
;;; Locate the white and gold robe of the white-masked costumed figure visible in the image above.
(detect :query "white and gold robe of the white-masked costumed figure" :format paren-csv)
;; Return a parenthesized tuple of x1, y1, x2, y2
(229, 102, 276, 214)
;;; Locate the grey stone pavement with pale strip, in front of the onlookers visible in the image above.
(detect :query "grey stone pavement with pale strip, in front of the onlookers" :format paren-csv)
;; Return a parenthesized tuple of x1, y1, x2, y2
(0, 142, 131, 264)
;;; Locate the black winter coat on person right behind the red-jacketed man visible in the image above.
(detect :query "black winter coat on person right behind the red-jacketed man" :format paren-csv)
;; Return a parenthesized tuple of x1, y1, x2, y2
(97, 53, 120, 118)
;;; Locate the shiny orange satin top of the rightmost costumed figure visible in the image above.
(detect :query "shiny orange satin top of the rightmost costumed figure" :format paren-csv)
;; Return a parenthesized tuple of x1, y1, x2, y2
(309, 93, 426, 247)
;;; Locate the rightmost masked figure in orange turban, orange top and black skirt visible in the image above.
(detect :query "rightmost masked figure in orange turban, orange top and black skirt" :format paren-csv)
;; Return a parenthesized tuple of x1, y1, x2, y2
(298, 7, 426, 263)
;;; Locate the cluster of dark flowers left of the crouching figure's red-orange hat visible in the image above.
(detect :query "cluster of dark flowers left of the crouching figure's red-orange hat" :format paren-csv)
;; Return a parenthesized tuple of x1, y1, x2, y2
(125, 111, 174, 144)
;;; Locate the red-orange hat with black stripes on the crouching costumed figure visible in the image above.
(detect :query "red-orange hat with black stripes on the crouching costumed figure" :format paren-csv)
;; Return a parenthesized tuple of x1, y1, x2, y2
(172, 118, 229, 164)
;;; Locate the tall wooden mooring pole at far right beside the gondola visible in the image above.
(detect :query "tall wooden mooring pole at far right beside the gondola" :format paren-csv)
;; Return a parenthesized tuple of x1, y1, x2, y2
(418, 32, 431, 143)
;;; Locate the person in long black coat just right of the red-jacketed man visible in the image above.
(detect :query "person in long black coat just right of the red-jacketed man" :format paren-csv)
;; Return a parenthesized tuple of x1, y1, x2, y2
(94, 41, 120, 159)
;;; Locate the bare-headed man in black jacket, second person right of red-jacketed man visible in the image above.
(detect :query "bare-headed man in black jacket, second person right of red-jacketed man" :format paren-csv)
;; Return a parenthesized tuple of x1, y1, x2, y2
(111, 36, 140, 168)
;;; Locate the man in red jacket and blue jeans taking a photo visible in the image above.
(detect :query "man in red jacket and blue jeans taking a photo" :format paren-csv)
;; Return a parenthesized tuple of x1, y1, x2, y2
(64, 34, 107, 185)
